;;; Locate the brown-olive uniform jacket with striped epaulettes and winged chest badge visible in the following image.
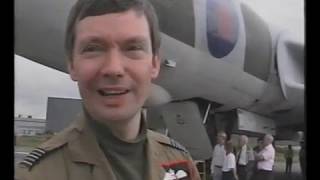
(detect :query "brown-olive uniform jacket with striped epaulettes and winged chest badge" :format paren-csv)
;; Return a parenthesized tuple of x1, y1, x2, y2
(15, 113, 200, 180)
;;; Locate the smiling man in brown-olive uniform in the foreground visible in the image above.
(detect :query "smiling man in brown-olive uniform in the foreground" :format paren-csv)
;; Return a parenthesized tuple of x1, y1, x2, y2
(15, 0, 200, 180)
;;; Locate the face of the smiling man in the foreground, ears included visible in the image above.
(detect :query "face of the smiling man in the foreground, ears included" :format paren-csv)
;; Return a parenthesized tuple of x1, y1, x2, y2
(68, 10, 160, 123)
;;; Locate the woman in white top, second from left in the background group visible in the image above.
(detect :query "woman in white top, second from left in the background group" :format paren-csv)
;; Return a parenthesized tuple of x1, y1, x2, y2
(222, 141, 238, 180)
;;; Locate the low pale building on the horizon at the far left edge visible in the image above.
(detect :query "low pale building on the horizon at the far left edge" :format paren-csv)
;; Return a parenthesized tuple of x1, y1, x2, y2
(14, 115, 46, 136)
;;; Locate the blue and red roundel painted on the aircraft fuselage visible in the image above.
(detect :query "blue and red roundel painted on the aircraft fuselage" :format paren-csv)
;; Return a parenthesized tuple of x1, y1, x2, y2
(207, 0, 239, 58)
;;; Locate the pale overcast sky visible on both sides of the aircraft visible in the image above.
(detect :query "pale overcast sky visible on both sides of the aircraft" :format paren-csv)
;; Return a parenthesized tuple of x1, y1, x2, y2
(14, 0, 305, 118)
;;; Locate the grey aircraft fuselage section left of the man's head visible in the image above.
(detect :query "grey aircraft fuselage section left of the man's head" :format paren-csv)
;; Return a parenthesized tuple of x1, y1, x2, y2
(14, 0, 75, 72)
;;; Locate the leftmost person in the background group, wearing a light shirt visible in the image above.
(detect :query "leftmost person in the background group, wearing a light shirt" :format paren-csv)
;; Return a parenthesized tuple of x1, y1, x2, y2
(210, 131, 227, 180)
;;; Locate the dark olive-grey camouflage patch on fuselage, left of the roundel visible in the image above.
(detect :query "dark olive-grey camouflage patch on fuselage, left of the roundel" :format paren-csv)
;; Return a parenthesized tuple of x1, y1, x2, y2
(150, 0, 195, 47)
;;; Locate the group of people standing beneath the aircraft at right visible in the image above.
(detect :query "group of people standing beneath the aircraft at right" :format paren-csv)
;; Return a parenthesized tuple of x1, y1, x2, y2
(210, 131, 275, 180)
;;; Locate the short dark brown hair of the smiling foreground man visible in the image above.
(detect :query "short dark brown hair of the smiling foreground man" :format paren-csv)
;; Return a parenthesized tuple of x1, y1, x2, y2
(65, 0, 160, 61)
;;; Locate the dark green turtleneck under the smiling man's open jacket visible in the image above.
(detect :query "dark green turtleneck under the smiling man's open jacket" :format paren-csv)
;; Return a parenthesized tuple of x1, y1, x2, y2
(88, 114, 147, 180)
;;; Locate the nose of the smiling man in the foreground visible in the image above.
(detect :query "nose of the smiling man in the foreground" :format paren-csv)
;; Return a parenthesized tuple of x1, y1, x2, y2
(101, 50, 124, 78)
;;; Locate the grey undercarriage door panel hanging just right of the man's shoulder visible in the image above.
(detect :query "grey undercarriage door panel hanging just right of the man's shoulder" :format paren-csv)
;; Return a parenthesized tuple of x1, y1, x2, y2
(147, 101, 212, 160)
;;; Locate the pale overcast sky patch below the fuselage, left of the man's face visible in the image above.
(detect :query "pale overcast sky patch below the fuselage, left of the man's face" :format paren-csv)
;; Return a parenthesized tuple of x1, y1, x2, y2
(14, 55, 80, 118)
